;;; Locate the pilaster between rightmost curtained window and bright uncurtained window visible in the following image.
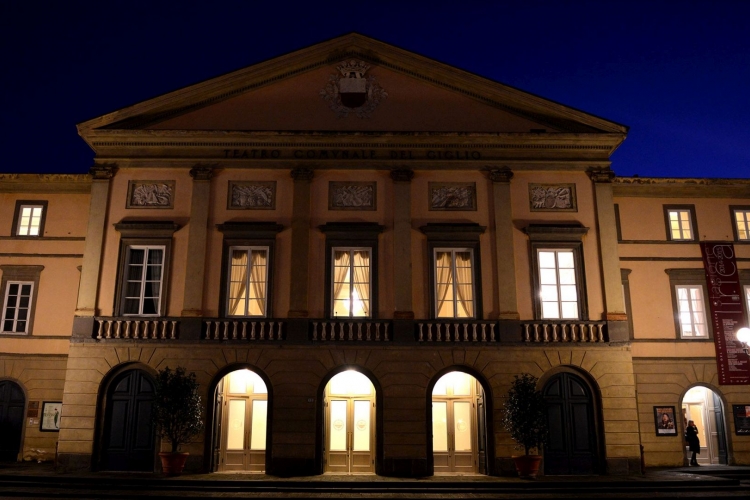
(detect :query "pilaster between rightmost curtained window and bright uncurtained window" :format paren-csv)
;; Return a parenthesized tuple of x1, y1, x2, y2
(488, 167, 519, 320)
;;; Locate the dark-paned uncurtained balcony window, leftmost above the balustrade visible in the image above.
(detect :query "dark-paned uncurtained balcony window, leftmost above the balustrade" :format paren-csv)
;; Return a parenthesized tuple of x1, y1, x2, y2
(123, 245, 165, 316)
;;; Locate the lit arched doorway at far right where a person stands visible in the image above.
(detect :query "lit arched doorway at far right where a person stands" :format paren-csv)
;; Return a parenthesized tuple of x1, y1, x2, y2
(682, 385, 728, 465)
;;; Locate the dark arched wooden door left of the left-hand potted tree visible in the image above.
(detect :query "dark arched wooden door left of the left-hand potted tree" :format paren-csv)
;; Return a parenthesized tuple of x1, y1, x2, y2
(102, 370, 155, 472)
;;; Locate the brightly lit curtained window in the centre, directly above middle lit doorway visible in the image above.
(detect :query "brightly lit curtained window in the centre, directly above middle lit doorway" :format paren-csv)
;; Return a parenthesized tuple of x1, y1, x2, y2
(331, 247, 372, 318)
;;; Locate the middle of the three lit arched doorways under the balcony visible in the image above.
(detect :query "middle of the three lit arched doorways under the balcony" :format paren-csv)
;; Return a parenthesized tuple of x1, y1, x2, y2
(323, 370, 376, 474)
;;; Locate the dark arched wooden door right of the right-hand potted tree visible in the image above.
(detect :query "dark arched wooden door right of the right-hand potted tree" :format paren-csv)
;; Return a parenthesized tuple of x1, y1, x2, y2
(544, 373, 598, 474)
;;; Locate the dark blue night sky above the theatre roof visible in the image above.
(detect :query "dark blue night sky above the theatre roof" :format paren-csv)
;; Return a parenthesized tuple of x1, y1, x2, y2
(0, 0, 750, 178)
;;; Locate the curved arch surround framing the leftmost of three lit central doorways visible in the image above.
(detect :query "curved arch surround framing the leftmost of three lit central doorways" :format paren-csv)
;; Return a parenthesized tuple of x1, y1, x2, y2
(203, 363, 273, 474)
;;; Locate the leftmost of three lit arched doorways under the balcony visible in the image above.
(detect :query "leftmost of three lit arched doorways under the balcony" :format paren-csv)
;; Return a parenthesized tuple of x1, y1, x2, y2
(214, 369, 268, 472)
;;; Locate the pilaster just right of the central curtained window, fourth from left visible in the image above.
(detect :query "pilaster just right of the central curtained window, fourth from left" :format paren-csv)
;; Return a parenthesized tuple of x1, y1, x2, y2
(391, 168, 414, 319)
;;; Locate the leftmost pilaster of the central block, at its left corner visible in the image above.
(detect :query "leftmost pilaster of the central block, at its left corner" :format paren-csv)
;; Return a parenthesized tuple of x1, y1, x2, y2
(75, 163, 117, 317)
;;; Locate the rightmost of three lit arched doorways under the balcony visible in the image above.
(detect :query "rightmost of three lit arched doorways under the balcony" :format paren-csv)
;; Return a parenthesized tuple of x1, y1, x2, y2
(432, 371, 487, 474)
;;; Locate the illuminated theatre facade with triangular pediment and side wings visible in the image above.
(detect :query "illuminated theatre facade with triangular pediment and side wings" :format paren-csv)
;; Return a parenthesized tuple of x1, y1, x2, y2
(0, 34, 750, 477)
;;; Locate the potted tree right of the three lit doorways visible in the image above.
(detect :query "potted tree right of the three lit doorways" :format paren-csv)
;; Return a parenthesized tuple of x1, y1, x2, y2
(503, 373, 549, 478)
